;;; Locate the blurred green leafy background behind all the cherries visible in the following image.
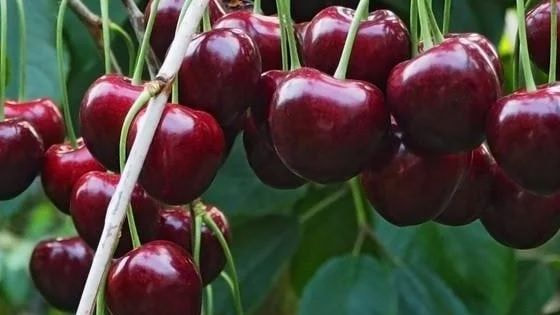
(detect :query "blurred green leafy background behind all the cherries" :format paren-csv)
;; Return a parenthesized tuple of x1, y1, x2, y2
(4, 0, 560, 315)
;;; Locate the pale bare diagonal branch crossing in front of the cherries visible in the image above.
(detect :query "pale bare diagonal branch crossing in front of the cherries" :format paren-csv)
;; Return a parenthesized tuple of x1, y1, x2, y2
(76, 0, 208, 315)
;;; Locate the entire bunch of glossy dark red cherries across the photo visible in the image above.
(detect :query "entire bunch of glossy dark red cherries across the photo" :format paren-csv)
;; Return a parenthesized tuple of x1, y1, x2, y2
(0, 0, 560, 315)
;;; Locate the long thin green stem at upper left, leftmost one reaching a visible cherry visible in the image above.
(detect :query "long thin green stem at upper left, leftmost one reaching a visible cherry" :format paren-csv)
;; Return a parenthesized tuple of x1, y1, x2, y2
(55, 0, 77, 148)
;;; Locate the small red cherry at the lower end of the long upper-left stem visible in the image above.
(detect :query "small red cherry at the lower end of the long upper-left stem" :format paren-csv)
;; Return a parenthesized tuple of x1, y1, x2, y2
(41, 139, 105, 214)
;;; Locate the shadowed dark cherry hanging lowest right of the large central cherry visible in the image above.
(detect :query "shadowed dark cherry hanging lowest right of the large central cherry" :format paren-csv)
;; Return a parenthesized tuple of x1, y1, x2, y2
(361, 127, 471, 226)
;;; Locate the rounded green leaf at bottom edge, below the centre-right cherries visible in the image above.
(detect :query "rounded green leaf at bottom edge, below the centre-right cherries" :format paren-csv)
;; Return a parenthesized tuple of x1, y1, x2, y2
(298, 256, 397, 315)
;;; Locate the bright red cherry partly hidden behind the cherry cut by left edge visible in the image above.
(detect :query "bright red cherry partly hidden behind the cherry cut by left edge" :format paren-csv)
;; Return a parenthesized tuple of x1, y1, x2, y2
(4, 98, 64, 150)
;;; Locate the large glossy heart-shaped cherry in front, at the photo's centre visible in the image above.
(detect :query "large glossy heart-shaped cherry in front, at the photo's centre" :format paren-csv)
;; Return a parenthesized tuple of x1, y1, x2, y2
(269, 68, 389, 184)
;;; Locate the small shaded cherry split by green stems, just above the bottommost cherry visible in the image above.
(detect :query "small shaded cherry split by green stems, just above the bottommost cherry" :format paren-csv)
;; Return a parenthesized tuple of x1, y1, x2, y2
(157, 206, 231, 285)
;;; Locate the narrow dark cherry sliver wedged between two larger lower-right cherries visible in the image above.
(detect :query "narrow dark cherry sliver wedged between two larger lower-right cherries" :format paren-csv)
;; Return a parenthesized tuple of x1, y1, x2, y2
(434, 146, 494, 226)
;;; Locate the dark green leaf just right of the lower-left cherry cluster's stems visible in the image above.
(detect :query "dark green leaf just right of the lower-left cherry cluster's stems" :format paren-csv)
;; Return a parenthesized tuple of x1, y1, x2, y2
(215, 216, 299, 315)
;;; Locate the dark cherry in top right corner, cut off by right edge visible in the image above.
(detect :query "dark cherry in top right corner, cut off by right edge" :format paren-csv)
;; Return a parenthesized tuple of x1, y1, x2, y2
(525, 1, 560, 74)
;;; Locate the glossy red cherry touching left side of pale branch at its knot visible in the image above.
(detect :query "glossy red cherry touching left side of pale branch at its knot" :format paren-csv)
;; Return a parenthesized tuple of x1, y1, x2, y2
(80, 75, 143, 172)
